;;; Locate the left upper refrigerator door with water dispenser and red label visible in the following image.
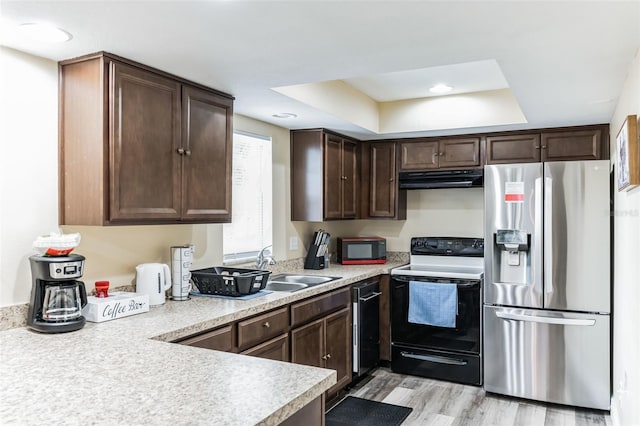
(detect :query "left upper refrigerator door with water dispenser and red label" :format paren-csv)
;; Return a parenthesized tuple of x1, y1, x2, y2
(484, 163, 543, 308)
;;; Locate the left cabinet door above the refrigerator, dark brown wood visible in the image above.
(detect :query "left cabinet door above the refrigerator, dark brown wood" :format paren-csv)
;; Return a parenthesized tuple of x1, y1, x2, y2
(486, 134, 540, 164)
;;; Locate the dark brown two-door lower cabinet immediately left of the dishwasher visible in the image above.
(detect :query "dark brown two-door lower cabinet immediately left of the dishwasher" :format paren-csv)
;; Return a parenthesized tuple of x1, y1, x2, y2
(291, 307, 351, 395)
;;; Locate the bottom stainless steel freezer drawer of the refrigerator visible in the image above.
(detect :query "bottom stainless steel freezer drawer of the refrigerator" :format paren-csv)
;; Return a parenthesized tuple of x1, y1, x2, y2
(484, 306, 611, 410)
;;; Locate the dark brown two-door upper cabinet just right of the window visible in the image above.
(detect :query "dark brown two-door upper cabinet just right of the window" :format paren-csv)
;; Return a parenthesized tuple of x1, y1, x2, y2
(291, 129, 358, 222)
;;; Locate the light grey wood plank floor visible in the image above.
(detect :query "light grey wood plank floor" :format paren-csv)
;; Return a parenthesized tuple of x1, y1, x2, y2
(348, 368, 611, 426)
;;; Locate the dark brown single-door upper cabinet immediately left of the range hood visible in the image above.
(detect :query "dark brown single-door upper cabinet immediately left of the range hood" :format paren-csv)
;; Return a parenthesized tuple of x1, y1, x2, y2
(360, 142, 407, 219)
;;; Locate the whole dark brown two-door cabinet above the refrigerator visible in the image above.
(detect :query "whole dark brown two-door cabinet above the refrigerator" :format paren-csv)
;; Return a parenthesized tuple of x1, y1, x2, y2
(486, 125, 609, 164)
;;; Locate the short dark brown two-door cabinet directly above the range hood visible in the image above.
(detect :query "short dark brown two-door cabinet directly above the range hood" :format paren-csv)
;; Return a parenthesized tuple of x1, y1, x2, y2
(400, 137, 482, 171)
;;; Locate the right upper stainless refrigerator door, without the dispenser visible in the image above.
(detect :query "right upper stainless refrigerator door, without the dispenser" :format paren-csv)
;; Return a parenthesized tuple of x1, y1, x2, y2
(544, 160, 611, 313)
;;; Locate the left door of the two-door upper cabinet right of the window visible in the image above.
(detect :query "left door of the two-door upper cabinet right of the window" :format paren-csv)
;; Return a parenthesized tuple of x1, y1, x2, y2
(318, 135, 343, 219)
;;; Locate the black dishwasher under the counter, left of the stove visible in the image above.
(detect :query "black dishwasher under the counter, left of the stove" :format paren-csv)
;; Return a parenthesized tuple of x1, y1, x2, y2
(351, 278, 380, 378)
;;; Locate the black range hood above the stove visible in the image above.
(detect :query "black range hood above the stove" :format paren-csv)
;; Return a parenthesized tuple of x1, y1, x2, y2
(398, 169, 484, 189)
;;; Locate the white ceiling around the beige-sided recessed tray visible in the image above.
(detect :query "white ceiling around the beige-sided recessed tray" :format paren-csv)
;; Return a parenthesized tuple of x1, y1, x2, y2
(0, 0, 640, 139)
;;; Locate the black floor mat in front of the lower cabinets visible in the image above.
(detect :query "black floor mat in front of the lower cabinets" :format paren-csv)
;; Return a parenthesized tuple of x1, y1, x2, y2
(325, 396, 413, 426)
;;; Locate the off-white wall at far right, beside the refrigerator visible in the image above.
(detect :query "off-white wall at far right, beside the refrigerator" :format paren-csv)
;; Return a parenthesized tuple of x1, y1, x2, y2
(611, 49, 640, 425)
